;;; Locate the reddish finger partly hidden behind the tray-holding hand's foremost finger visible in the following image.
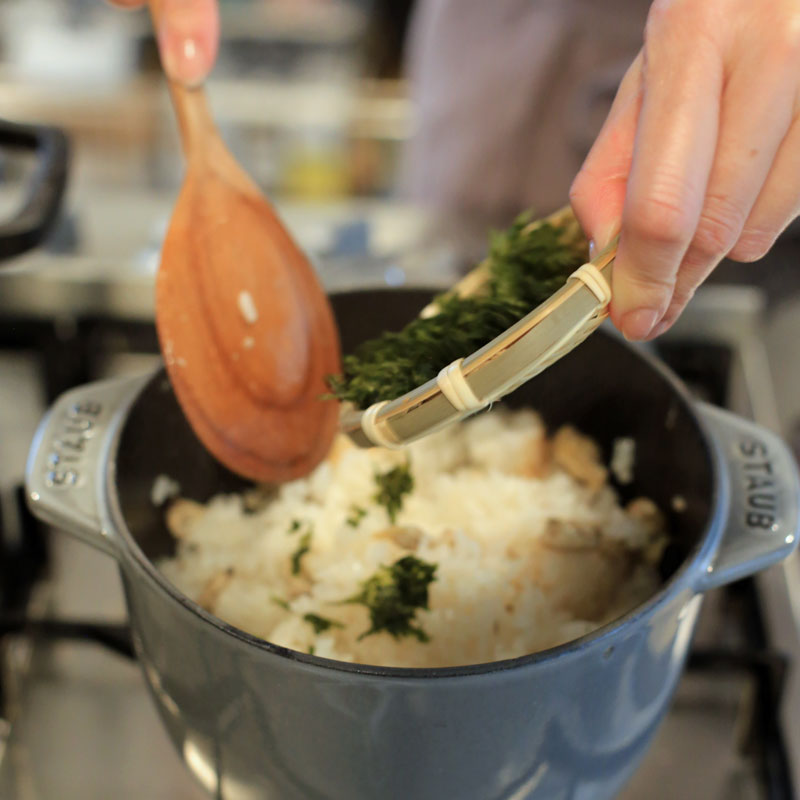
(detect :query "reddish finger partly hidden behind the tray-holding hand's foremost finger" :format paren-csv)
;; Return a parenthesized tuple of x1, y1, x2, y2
(569, 53, 643, 250)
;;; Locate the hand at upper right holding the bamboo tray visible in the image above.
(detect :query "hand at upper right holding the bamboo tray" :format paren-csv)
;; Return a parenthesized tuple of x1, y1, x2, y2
(570, 0, 800, 339)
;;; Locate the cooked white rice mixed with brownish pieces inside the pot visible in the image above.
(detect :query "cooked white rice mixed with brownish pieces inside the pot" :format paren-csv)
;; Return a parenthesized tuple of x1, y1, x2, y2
(160, 409, 666, 667)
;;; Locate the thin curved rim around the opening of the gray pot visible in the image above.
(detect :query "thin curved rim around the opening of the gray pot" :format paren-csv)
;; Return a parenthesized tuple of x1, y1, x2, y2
(101, 322, 729, 680)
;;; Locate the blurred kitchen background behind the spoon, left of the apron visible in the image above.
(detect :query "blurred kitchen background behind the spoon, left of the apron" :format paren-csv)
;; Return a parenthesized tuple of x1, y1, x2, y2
(0, 0, 422, 278)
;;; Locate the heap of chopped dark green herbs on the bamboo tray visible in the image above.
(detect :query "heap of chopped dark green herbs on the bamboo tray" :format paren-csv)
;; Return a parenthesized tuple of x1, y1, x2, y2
(328, 213, 587, 408)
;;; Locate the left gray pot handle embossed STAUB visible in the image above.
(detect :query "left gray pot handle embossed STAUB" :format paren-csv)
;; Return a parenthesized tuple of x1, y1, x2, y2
(25, 375, 150, 555)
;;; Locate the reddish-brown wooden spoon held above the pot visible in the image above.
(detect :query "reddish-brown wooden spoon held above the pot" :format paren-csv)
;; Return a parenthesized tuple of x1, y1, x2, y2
(150, 0, 340, 482)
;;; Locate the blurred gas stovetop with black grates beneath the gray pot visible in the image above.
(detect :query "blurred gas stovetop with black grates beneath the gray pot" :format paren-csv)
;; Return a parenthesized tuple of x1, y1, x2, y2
(0, 287, 800, 800)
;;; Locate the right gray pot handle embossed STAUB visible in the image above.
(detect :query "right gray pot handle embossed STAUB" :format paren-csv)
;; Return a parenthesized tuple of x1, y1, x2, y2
(697, 403, 800, 591)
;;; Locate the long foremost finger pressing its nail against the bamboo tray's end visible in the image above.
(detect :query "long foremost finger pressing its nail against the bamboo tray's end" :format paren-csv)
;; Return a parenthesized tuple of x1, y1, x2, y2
(611, 4, 723, 339)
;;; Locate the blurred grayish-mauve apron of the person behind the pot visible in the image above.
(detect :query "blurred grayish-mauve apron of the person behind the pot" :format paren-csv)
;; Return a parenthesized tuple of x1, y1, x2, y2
(403, 0, 649, 258)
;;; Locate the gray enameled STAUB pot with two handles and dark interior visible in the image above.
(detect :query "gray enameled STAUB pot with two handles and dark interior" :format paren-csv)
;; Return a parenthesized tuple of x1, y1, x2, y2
(27, 290, 799, 800)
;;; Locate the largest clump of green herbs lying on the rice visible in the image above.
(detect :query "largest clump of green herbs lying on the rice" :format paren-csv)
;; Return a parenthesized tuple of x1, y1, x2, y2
(345, 556, 436, 642)
